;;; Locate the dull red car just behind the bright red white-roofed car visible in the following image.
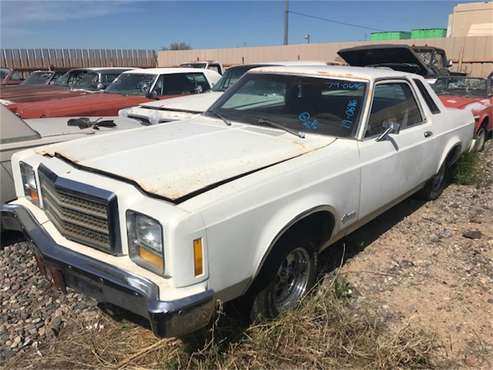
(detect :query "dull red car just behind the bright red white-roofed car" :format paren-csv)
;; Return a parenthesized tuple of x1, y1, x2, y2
(0, 67, 131, 110)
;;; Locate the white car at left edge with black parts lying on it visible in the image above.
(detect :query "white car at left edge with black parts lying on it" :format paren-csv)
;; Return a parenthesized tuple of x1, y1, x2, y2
(0, 105, 141, 203)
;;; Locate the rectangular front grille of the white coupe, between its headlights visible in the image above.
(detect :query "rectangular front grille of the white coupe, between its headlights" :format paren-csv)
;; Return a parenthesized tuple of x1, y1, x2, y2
(39, 168, 115, 253)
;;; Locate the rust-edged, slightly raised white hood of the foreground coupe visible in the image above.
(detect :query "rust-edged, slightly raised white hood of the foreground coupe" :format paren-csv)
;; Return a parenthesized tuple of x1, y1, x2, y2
(37, 116, 335, 203)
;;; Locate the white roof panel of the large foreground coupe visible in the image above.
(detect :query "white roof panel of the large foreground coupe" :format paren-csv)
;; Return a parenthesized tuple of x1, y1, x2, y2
(247, 65, 421, 80)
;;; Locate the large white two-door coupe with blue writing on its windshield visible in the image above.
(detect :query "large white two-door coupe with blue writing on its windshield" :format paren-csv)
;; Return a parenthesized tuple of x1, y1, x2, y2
(1, 66, 474, 336)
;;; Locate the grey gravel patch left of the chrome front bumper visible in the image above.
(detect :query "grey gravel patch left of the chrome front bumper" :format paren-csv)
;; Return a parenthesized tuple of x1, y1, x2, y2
(0, 243, 99, 363)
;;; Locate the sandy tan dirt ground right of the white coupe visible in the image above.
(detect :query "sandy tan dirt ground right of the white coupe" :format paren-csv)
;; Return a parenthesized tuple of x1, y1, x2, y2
(334, 143, 493, 369)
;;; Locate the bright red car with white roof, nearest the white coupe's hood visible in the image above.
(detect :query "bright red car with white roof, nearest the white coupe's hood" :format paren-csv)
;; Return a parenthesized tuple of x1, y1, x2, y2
(12, 68, 221, 119)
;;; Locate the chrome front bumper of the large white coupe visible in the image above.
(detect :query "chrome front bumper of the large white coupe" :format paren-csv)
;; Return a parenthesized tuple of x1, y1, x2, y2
(0, 204, 215, 337)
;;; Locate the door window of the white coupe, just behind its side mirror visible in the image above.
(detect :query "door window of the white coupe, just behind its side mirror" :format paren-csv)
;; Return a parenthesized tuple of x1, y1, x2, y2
(365, 82, 423, 137)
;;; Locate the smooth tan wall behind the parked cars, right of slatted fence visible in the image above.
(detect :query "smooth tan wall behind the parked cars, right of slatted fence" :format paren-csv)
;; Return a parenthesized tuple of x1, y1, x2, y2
(158, 37, 493, 77)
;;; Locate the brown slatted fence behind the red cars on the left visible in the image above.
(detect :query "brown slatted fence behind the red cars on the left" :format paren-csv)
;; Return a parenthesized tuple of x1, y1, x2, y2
(0, 49, 157, 72)
